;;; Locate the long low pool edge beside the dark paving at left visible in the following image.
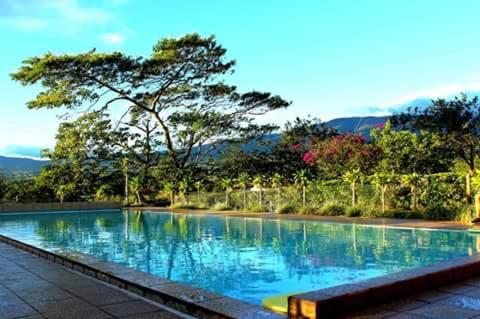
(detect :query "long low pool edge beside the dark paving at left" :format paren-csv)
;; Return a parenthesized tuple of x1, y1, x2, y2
(0, 235, 285, 319)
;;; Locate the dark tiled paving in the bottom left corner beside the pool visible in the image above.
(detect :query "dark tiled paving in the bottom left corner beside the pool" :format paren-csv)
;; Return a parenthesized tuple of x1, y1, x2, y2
(0, 243, 184, 319)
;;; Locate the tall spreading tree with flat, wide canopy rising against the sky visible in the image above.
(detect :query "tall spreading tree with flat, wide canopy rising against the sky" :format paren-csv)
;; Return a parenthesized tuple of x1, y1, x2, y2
(12, 34, 289, 182)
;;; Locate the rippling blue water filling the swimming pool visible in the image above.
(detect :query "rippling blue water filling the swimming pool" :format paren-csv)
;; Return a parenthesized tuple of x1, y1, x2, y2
(0, 212, 479, 304)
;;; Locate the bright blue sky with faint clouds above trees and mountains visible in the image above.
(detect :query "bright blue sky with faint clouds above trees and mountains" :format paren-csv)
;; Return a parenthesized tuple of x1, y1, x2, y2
(0, 0, 480, 154)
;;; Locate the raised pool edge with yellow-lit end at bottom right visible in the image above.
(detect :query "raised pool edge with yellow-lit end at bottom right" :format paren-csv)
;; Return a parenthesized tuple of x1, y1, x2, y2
(288, 256, 480, 319)
